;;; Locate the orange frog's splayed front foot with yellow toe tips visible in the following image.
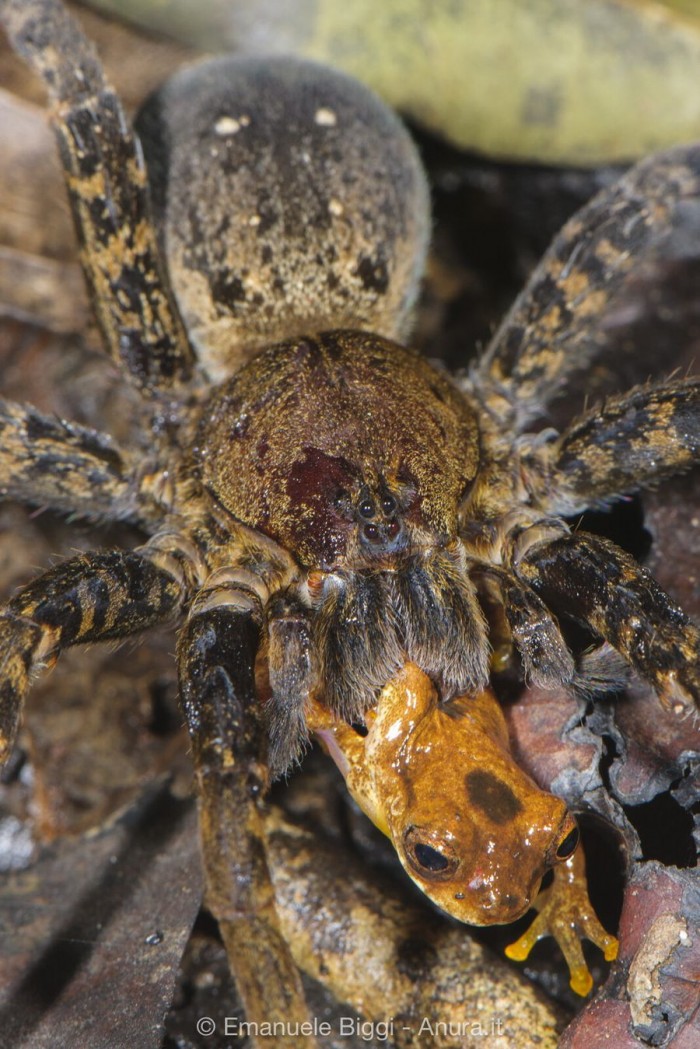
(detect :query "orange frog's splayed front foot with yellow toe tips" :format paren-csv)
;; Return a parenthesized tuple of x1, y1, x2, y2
(506, 848, 618, 996)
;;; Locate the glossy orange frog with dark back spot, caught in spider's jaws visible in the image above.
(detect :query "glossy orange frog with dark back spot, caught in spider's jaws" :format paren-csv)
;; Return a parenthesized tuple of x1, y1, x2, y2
(309, 663, 617, 994)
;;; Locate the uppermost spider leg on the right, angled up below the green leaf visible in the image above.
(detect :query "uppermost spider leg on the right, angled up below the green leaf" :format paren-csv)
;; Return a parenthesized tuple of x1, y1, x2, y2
(471, 145, 700, 432)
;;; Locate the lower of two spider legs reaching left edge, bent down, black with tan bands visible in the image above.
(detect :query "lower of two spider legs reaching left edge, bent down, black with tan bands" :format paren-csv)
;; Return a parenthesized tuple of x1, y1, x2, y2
(0, 547, 185, 763)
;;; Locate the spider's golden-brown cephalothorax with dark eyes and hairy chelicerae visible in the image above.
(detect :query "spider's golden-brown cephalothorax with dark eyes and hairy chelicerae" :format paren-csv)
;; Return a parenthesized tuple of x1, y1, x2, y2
(196, 331, 488, 738)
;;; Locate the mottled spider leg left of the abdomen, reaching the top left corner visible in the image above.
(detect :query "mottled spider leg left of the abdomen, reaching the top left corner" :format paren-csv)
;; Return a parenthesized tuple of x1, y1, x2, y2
(0, 0, 193, 397)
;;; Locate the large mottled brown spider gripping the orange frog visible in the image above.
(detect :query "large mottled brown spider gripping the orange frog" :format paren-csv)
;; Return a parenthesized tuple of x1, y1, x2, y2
(0, 0, 700, 1040)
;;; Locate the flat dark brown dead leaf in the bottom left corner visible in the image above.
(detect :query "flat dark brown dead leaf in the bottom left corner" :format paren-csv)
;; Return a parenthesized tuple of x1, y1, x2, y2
(0, 789, 201, 1049)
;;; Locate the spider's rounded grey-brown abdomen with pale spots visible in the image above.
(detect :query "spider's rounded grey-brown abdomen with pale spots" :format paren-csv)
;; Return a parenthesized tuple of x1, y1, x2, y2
(136, 56, 430, 380)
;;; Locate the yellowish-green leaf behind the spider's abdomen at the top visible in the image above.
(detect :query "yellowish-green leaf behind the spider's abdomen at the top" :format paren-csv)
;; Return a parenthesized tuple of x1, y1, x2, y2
(92, 0, 700, 166)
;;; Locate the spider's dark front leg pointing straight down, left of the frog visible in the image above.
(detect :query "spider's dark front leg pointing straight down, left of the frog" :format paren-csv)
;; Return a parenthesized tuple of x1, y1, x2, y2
(177, 587, 313, 1047)
